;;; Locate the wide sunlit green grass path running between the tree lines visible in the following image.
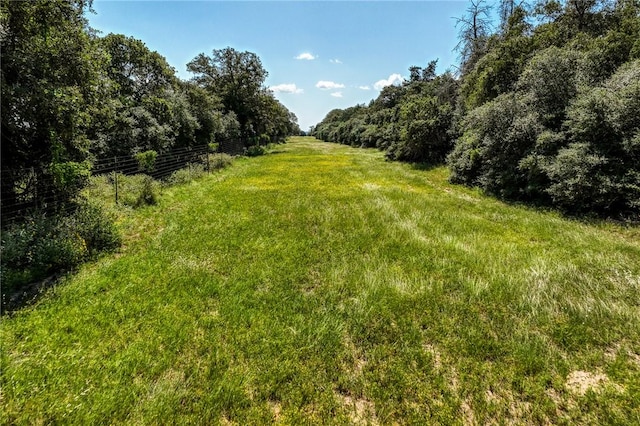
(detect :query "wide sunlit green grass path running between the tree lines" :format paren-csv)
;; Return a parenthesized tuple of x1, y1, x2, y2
(0, 138, 640, 424)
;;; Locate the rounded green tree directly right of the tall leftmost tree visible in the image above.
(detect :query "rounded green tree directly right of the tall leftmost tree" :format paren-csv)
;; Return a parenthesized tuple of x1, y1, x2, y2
(90, 34, 181, 157)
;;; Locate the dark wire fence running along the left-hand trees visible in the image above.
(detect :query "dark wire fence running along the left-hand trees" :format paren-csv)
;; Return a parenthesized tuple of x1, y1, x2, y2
(0, 141, 243, 227)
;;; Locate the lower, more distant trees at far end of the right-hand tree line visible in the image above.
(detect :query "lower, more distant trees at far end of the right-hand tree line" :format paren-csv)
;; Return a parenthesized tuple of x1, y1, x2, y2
(312, 68, 458, 164)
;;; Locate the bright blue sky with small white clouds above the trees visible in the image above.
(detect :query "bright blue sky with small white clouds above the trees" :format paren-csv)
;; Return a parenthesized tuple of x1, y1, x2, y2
(87, 0, 468, 130)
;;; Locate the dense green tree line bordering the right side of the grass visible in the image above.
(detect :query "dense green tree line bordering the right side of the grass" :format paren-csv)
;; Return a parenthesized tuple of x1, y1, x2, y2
(312, 0, 640, 217)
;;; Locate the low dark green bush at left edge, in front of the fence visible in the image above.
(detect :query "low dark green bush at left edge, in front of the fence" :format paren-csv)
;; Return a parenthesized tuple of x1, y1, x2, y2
(1, 201, 120, 294)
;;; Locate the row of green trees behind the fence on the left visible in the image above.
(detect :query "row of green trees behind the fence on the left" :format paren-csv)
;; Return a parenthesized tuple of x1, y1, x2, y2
(0, 0, 299, 220)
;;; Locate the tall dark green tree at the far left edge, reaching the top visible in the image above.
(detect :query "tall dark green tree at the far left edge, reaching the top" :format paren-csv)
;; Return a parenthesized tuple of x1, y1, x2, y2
(0, 0, 106, 220)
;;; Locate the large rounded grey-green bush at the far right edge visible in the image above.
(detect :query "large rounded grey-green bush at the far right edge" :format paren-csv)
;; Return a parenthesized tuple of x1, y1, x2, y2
(545, 60, 640, 214)
